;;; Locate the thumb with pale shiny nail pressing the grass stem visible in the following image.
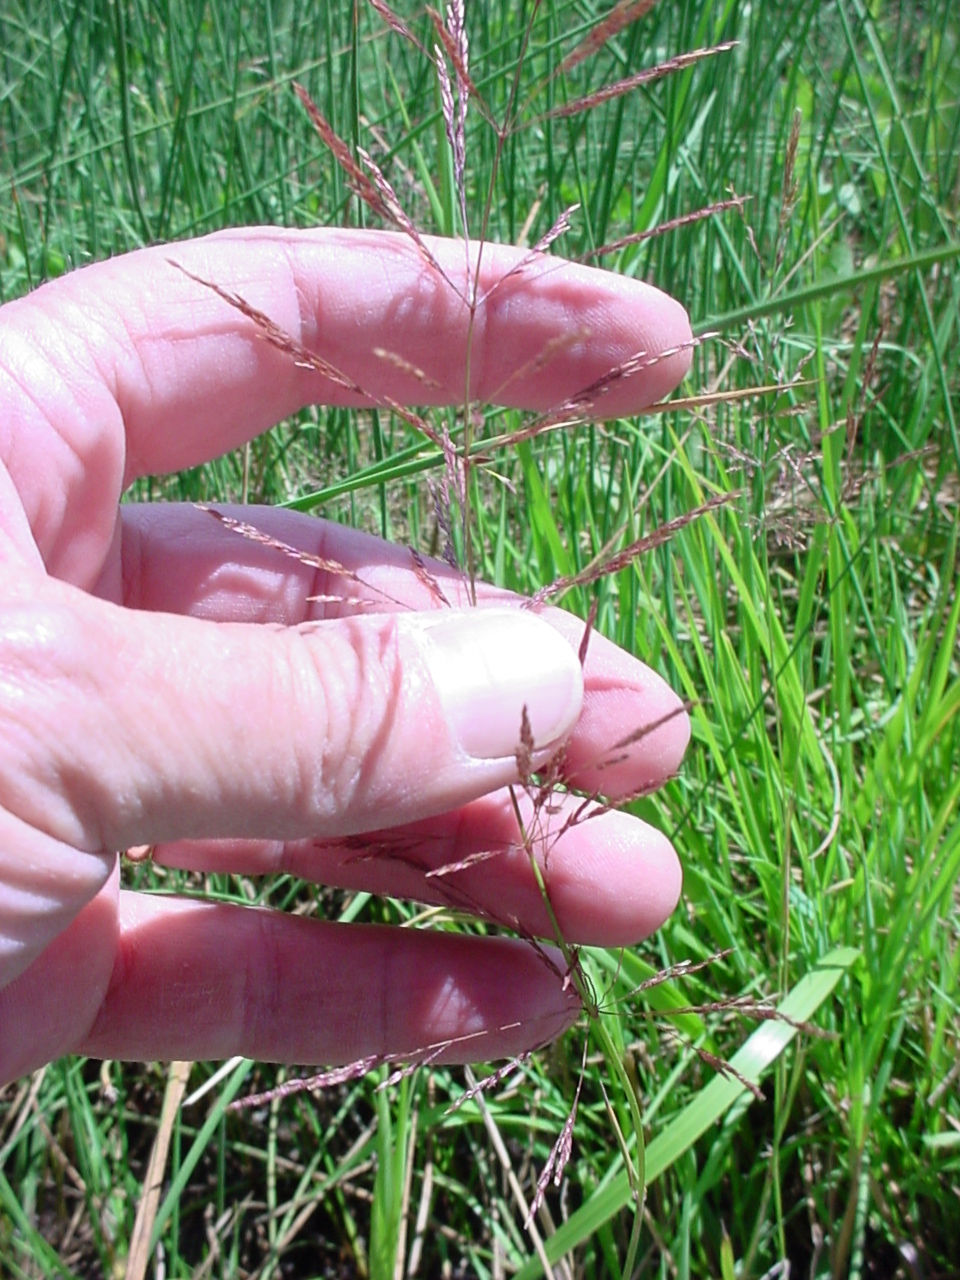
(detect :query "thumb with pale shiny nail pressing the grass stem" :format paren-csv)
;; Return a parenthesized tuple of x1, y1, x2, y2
(0, 580, 582, 854)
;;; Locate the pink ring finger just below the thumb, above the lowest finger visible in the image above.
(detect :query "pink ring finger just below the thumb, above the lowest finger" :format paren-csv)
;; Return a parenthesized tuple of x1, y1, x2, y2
(155, 791, 681, 946)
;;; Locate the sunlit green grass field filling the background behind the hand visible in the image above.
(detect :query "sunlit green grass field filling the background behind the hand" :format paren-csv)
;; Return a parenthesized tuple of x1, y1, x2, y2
(0, 0, 960, 1280)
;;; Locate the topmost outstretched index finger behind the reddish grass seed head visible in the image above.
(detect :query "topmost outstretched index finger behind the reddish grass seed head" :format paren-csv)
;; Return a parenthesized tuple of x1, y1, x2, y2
(5, 228, 690, 486)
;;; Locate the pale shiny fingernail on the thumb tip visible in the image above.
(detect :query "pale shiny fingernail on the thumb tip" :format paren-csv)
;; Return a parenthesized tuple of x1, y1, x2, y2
(411, 608, 584, 760)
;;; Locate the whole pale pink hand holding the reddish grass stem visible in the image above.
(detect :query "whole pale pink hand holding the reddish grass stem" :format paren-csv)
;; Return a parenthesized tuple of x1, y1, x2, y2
(0, 229, 690, 1082)
